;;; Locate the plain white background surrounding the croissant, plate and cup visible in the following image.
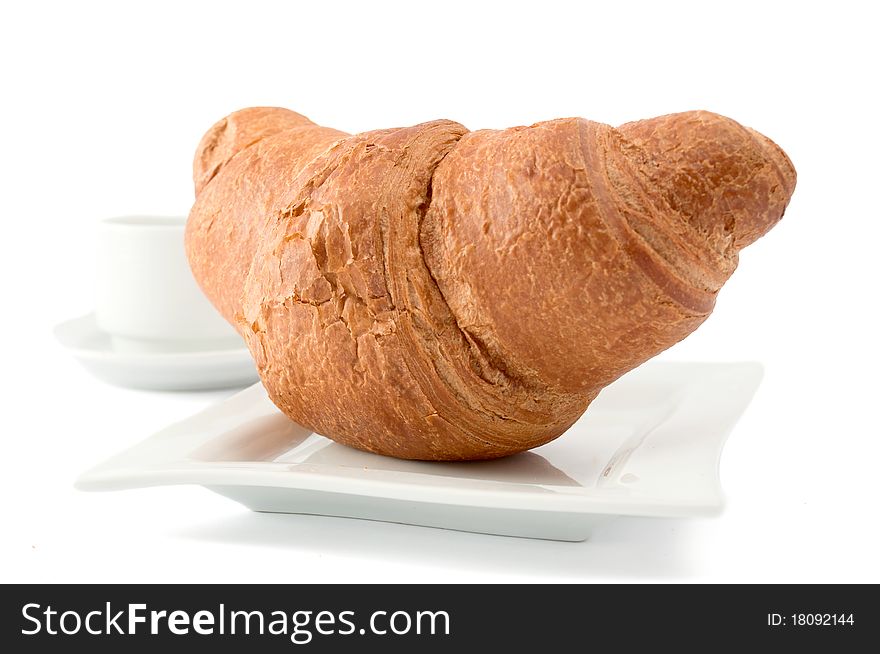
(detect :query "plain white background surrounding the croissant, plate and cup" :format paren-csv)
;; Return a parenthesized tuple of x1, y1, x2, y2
(0, 0, 880, 582)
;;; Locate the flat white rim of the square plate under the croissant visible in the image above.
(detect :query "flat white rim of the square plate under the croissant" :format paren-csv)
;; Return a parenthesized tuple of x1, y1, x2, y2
(76, 362, 762, 517)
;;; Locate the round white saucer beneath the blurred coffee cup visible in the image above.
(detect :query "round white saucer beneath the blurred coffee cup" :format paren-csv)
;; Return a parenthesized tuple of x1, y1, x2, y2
(54, 313, 258, 391)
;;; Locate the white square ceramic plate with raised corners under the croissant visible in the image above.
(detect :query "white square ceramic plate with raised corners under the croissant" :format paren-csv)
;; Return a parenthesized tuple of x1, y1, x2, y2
(77, 361, 762, 540)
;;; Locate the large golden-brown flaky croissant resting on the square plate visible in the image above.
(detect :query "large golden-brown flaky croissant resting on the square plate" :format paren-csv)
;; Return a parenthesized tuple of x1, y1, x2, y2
(186, 108, 795, 460)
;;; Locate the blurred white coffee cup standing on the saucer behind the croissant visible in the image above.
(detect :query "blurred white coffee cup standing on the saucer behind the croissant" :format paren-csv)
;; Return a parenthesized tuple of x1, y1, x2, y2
(95, 216, 241, 352)
